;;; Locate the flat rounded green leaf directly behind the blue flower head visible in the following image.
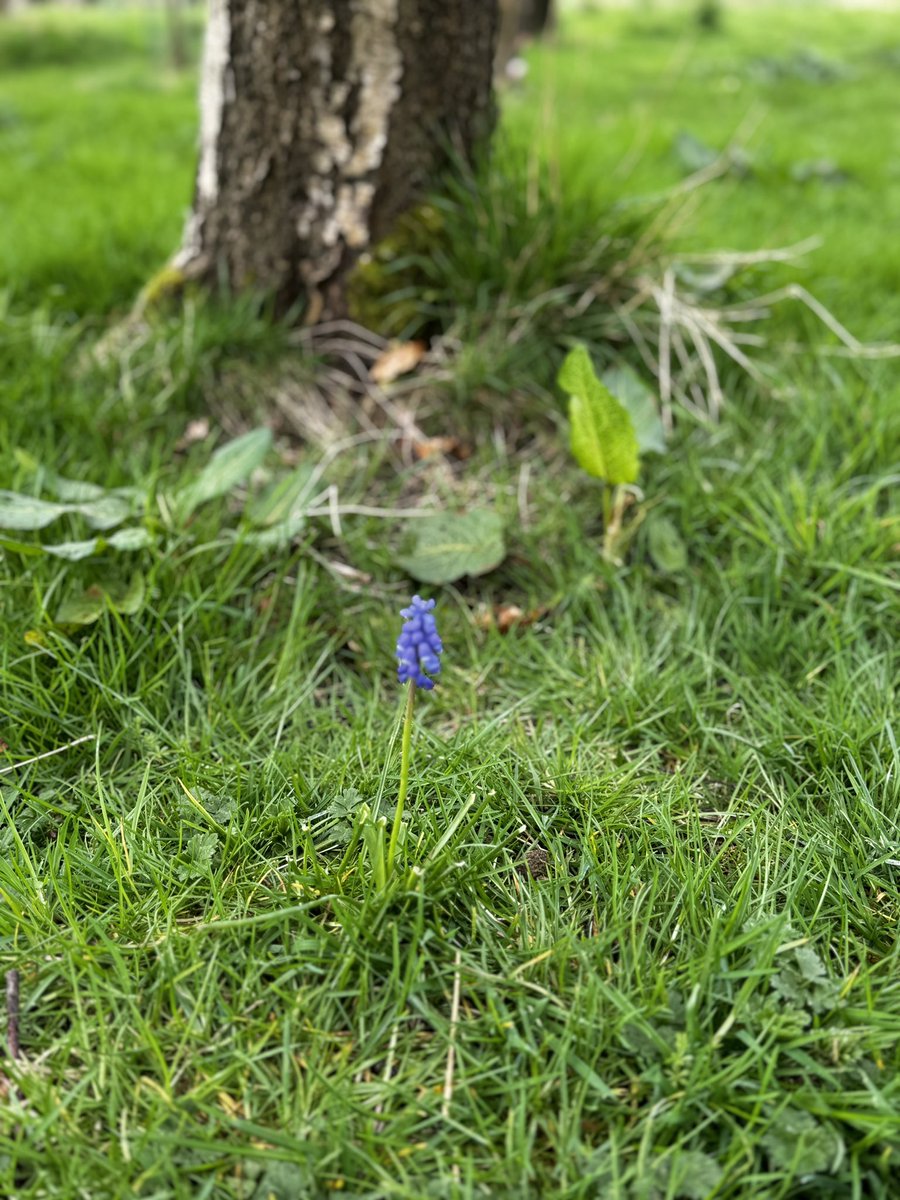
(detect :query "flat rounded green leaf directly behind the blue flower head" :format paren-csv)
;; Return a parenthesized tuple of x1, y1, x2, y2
(397, 509, 506, 583)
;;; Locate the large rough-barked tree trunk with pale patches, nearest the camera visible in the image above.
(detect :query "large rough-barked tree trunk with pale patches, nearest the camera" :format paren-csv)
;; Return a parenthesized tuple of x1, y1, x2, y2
(174, 0, 496, 314)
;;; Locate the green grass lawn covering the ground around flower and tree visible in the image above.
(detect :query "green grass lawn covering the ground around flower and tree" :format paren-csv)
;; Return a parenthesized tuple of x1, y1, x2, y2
(0, 10, 900, 1200)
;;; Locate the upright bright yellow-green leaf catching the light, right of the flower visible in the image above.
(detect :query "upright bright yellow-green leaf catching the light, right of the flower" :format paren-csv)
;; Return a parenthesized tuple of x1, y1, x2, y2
(558, 346, 638, 485)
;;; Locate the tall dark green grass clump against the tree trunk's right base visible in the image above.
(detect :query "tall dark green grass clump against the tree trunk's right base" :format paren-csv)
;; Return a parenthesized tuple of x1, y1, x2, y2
(352, 149, 659, 388)
